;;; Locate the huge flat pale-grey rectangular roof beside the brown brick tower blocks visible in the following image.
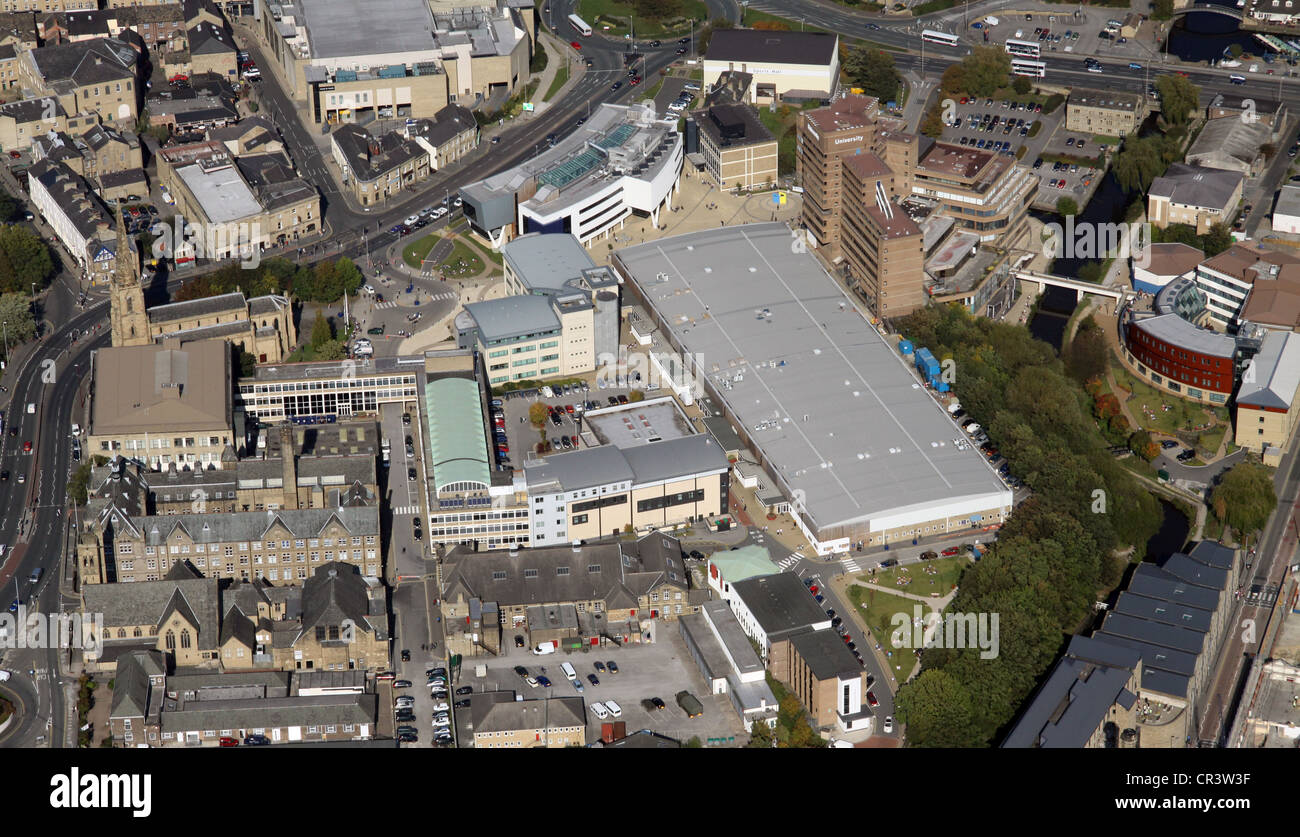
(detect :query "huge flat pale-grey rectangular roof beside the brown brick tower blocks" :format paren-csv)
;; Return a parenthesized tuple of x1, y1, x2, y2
(614, 224, 1011, 530)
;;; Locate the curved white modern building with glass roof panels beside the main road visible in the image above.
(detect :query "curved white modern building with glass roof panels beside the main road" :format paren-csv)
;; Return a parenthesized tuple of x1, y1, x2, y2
(460, 104, 684, 248)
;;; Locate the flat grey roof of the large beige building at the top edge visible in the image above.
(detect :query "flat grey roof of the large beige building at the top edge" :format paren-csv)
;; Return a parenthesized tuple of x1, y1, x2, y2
(294, 0, 433, 58)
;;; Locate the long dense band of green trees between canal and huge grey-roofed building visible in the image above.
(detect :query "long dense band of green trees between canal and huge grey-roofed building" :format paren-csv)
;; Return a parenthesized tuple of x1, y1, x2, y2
(897, 305, 1160, 747)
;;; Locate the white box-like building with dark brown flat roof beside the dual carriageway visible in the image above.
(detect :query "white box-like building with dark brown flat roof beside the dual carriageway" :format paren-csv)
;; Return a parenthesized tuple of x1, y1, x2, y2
(703, 29, 840, 104)
